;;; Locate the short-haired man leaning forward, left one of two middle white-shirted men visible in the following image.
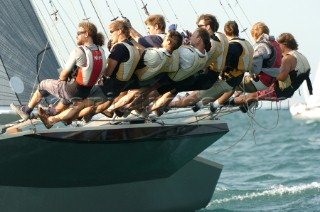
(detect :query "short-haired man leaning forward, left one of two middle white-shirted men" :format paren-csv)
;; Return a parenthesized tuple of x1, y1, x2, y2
(103, 31, 183, 117)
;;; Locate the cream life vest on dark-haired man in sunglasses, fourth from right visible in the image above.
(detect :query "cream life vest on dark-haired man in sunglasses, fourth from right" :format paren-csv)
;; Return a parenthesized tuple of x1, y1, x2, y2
(205, 32, 229, 73)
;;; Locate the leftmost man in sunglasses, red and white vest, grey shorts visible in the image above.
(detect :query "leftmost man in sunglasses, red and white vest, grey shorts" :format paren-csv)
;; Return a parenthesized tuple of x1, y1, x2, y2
(11, 21, 106, 119)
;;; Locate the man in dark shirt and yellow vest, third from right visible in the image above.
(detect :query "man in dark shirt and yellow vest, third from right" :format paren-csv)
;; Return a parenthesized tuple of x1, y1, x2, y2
(170, 21, 253, 110)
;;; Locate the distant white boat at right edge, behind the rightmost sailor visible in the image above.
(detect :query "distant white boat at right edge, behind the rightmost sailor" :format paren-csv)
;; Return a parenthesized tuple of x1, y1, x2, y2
(290, 60, 320, 121)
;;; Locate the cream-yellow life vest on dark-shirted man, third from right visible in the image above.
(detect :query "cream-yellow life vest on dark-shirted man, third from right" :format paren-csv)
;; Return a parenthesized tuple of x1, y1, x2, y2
(224, 39, 253, 79)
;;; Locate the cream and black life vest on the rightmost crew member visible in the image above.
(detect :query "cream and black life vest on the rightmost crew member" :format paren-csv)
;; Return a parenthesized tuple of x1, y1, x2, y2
(274, 50, 312, 98)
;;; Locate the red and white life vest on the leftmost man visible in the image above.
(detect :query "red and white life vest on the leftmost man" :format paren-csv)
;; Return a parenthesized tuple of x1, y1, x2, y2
(75, 46, 106, 87)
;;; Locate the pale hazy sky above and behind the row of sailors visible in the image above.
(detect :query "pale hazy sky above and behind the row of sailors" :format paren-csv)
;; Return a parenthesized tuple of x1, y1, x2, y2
(32, 0, 320, 104)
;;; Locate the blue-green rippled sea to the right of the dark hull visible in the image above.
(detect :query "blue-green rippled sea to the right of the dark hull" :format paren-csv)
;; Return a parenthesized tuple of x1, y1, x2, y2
(199, 110, 320, 212)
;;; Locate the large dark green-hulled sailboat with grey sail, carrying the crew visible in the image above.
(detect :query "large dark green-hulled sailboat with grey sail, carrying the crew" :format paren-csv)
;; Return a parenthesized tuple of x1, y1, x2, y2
(0, 0, 229, 211)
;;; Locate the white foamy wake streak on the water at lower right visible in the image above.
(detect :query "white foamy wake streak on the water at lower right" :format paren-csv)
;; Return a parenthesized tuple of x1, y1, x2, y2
(206, 182, 320, 209)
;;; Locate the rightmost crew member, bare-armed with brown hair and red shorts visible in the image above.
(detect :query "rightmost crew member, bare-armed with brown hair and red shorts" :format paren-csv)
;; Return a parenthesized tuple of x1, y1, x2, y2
(233, 33, 312, 108)
